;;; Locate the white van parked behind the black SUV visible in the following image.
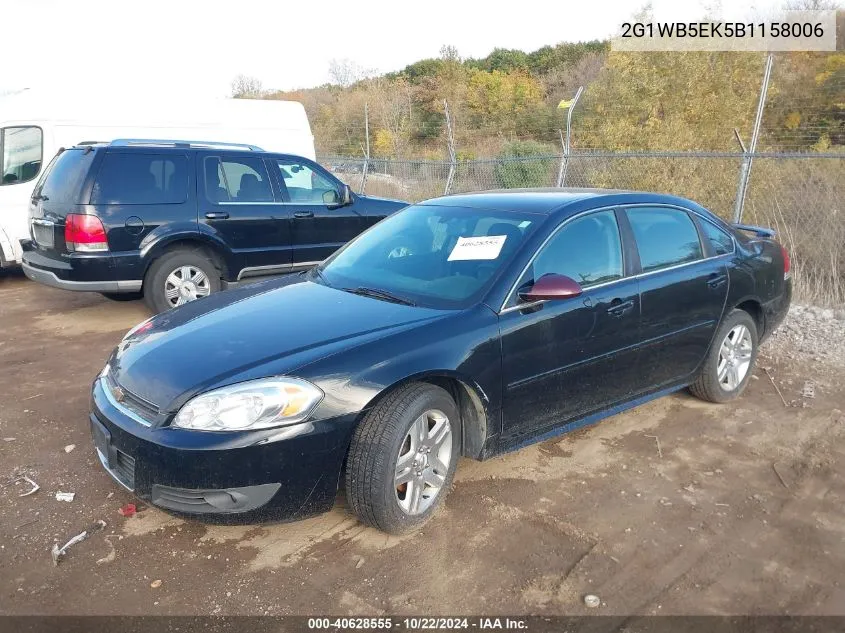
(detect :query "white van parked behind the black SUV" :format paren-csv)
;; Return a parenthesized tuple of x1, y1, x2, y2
(0, 89, 315, 267)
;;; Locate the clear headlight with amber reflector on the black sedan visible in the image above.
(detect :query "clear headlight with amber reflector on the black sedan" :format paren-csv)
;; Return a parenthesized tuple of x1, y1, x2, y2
(172, 377, 323, 431)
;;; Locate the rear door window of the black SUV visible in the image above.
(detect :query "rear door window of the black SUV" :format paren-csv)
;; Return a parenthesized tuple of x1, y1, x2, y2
(205, 156, 274, 203)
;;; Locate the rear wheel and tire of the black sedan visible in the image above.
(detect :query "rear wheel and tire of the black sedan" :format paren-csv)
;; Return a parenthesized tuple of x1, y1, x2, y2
(690, 310, 759, 402)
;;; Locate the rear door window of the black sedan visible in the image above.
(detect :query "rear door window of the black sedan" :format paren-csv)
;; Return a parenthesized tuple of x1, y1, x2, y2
(628, 208, 702, 272)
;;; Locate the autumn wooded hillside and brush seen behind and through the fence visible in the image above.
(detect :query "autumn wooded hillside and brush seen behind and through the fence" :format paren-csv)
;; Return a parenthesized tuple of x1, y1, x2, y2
(234, 27, 845, 305)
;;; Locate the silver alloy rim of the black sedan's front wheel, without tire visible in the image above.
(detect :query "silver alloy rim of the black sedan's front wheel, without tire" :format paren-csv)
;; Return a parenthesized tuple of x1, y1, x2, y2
(394, 409, 452, 515)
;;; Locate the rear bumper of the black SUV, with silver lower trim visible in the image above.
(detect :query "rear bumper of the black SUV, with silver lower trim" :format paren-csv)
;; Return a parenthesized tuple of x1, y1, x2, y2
(21, 251, 144, 292)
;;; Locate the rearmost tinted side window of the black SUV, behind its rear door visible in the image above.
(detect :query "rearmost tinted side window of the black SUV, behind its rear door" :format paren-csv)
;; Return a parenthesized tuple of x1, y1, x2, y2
(91, 152, 188, 204)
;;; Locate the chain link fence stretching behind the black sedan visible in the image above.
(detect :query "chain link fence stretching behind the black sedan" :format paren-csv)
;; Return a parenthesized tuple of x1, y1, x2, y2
(321, 151, 845, 305)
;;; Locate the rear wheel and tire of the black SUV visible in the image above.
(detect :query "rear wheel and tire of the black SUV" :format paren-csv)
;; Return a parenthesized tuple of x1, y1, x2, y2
(144, 248, 221, 314)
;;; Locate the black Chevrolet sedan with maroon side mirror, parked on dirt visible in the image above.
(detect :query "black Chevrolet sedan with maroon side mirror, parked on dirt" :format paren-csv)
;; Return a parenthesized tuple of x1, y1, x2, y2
(90, 190, 792, 533)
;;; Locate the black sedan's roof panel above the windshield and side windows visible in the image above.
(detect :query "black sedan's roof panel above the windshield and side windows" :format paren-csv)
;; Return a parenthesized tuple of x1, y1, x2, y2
(419, 188, 705, 215)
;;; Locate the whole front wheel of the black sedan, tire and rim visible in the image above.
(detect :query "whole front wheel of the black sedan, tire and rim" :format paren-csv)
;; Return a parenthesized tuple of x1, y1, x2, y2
(346, 383, 461, 534)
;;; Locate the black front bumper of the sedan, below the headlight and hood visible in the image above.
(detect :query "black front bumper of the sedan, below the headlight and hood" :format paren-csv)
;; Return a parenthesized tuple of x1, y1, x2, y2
(90, 379, 355, 522)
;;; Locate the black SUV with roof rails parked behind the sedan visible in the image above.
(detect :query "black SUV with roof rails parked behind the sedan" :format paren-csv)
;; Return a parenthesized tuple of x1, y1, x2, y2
(23, 140, 407, 312)
